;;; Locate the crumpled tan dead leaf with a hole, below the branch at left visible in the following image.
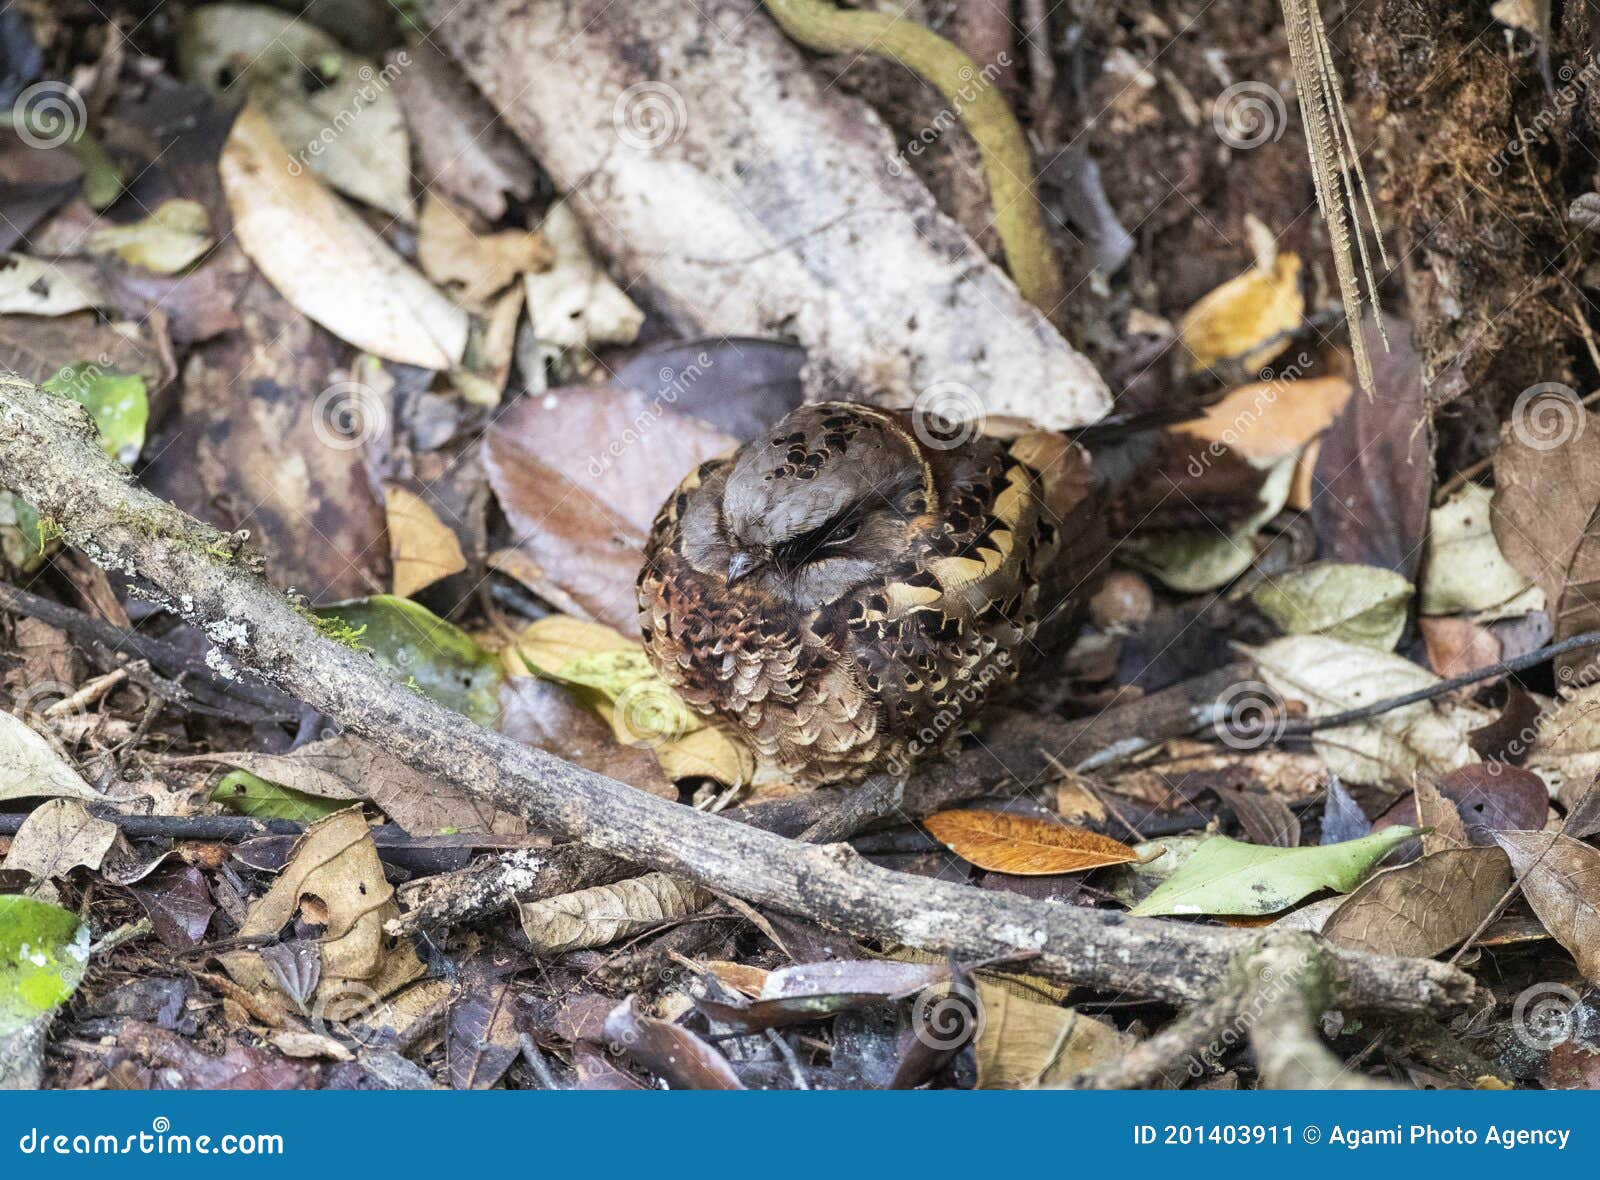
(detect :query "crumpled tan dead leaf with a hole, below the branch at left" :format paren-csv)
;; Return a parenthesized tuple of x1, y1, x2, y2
(219, 807, 424, 1006)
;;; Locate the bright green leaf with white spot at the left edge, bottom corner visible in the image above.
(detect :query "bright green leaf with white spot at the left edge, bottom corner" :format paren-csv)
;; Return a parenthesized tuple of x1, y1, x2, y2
(0, 894, 90, 1039)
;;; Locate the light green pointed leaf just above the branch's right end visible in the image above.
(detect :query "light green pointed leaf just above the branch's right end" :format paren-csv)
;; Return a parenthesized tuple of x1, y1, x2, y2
(1130, 825, 1418, 918)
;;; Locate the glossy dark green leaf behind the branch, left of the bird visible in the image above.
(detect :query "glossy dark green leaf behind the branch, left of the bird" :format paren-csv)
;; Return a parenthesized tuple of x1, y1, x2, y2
(312, 595, 502, 728)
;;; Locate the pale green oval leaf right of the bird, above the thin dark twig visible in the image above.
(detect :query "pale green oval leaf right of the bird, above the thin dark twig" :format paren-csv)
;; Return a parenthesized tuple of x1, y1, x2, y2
(1251, 561, 1411, 651)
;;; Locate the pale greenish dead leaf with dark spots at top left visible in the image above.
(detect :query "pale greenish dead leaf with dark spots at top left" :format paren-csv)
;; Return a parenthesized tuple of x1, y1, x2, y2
(178, 5, 416, 221)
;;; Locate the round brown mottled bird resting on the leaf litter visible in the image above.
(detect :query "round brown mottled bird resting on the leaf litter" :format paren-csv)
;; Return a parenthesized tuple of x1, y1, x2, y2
(637, 401, 1109, 788)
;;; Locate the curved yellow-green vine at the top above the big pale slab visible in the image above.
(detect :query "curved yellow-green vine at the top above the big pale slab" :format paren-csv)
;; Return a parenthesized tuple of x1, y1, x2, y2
(765, 0, 1066, 315)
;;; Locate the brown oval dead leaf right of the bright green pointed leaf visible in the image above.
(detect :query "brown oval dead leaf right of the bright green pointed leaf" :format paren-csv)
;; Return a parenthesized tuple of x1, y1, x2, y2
(1322, 847, 1510, 958)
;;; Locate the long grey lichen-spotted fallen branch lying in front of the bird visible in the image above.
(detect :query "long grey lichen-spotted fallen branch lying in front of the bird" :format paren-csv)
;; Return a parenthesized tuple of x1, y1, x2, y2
(0, 377, 1475, 1012)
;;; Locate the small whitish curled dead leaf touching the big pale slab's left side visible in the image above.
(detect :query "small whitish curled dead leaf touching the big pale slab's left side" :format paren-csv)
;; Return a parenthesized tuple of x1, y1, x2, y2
(523, 201, 645, 352)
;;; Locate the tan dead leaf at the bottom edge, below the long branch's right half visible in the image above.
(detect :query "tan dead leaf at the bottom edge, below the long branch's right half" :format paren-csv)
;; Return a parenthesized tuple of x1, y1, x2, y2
(976, 980, 1134, 1090)
